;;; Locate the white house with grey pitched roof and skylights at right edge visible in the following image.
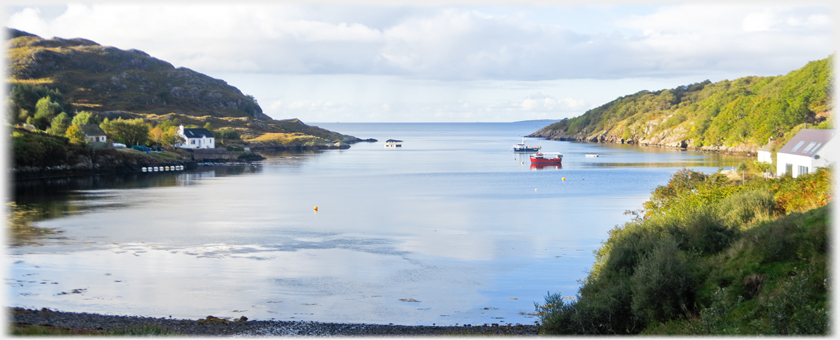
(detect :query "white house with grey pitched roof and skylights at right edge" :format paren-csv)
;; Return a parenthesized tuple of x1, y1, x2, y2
(776, 129, 840, 177)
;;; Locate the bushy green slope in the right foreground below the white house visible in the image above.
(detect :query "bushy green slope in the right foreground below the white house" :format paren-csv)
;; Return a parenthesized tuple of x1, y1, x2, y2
(537, 169, 833, 335)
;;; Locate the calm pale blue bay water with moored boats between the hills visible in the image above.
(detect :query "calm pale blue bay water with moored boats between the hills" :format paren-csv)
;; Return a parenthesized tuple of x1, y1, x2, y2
(5, 122, 742, 325)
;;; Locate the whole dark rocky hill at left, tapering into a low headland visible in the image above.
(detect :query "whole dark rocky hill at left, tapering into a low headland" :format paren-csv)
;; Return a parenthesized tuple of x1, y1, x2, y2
(6, 29, 356, 142)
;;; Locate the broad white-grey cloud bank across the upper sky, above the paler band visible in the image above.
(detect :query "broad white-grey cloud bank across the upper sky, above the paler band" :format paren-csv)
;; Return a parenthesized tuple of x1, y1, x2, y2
(8, 3, 834, 81)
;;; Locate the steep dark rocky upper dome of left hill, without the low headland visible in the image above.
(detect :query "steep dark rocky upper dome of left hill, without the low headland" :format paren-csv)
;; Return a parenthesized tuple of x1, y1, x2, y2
(6, 29, 270, 120)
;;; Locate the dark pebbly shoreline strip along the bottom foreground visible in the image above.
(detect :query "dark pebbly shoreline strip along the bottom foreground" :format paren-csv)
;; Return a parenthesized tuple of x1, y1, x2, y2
(8, 308, 539, 336)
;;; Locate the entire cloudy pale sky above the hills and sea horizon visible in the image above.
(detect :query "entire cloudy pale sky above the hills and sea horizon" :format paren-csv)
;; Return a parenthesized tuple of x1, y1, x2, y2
(3, 1, 837, 123)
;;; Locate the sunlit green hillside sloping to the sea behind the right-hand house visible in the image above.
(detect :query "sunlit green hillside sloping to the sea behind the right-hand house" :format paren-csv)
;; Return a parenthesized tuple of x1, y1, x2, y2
(528, 56, 834, 152)
